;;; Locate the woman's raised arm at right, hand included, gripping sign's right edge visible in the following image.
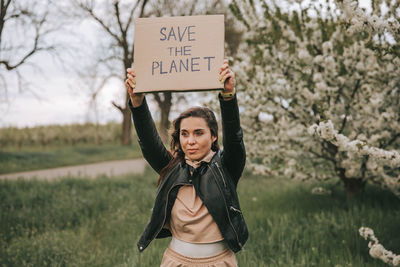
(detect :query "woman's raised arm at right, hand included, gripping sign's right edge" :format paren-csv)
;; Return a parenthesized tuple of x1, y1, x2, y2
(219, 60, 246, 184)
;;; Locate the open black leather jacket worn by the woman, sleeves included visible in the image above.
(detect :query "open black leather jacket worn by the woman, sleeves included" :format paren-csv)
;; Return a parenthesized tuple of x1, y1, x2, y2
(129, 97, 248, 252)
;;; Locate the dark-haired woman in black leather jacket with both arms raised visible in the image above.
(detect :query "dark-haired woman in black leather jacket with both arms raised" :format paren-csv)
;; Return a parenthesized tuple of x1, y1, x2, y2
(125, 60, 248, 267)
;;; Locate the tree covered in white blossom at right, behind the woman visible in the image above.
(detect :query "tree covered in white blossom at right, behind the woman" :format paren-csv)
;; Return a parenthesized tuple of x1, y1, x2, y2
(230, 0, 400, 196)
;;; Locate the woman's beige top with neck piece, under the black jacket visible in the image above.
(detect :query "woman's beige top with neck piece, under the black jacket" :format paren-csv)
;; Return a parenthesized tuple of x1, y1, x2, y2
(166, 151, 224, 243)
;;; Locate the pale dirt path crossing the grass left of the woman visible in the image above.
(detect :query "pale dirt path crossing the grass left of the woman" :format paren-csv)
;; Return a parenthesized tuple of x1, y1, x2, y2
(0, 159, 147, 180)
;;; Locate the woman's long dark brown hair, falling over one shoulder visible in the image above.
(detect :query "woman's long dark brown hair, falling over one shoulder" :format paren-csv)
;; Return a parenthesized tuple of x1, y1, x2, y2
(157, 107, 219, 185)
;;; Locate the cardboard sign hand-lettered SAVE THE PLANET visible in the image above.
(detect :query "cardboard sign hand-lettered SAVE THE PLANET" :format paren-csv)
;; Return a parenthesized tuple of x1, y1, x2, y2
(134, 15, 225, 92)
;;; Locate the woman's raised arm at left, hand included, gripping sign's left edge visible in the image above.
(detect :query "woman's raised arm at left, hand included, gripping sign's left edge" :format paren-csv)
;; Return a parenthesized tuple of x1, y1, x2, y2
(125, 68, 171, 173)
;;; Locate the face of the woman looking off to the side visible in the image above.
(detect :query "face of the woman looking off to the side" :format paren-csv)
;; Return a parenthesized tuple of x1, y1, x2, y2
(179, 117, 217, 160)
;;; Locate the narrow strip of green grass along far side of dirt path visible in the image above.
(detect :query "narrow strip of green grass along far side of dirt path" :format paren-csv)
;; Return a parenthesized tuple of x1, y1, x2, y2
(0, 142, 142, 174)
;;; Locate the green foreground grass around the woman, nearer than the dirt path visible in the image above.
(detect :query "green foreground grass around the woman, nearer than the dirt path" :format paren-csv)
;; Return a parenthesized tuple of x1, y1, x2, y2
(0, 170, 400, 267)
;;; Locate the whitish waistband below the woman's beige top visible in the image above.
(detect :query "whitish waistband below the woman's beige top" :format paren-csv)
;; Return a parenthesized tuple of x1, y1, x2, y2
(169, 237, 229, 258)
